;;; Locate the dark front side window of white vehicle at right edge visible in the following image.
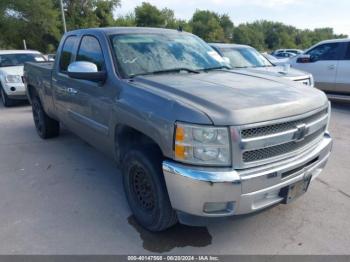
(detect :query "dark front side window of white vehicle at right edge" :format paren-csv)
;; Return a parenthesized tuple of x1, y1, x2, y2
(307, 43, 342, 62)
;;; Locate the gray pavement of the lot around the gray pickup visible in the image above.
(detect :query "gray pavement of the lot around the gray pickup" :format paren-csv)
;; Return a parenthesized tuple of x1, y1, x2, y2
(0, 100, 350, 255)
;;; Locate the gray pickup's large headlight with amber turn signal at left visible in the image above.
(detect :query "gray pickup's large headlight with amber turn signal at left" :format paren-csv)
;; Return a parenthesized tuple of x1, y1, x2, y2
(175, 123, 231, 166)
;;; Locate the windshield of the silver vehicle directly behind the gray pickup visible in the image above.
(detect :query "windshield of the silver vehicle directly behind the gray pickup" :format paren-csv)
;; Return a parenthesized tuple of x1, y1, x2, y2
(221, 48, 273, 68)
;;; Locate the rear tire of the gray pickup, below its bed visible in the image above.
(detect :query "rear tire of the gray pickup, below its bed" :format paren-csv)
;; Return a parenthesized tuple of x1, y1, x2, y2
(32, 96, 60, 139)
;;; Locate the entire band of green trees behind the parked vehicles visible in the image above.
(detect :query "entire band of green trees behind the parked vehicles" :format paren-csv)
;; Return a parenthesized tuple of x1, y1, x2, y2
(0, 0, 347, 52)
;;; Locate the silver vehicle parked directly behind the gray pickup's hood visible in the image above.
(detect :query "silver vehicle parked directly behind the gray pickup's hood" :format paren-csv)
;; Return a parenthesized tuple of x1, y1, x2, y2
(210, 44, 314, 86)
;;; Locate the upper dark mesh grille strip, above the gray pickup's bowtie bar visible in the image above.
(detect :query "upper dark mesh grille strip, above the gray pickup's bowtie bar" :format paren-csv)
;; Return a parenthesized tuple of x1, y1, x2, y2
(241, 109, 327, 138)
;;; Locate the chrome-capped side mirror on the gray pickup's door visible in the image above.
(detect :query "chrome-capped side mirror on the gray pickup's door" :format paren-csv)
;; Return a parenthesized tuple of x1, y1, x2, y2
(67, 61, 107, 82)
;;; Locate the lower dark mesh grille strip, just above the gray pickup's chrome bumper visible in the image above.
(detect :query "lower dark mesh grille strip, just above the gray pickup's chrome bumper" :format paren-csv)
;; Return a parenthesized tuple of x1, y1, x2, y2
(243, 126, 326, 163)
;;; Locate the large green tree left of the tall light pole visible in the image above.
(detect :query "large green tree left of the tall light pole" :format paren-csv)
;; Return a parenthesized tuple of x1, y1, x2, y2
(0, 0, 60, 52)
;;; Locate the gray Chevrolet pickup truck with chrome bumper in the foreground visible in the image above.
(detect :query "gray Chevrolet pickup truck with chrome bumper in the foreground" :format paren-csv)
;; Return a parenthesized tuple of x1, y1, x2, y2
(24, 28, 332, 231)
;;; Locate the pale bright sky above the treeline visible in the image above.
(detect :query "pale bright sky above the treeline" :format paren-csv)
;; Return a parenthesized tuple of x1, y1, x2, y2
(115, 0, 350, 37)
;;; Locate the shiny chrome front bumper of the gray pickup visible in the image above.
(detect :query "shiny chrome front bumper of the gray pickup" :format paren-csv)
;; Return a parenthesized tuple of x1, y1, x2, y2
(163, 134, 332, 217)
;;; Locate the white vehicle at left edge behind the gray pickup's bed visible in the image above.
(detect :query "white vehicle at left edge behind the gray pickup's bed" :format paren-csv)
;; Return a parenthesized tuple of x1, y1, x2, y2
(0, 50, 46, 107)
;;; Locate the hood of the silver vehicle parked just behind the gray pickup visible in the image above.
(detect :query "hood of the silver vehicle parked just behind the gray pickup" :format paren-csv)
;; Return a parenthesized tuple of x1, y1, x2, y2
(238, 66, 310, 80)
